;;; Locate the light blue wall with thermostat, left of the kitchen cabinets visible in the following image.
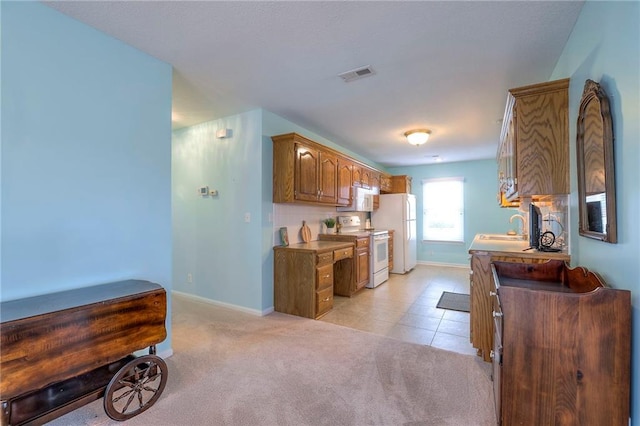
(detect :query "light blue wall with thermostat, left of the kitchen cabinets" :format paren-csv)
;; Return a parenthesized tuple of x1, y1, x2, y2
(172, 110, 273, 313)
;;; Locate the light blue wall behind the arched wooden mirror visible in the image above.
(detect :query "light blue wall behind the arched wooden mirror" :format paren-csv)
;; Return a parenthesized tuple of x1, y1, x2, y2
(552, 1, 640, 425)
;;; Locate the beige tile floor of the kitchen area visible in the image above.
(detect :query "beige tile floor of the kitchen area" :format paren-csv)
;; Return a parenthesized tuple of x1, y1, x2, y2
(321, 265, 476, 355)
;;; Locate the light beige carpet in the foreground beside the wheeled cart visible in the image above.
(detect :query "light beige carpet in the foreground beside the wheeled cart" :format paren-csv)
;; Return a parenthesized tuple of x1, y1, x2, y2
(50, 295, 496, 426)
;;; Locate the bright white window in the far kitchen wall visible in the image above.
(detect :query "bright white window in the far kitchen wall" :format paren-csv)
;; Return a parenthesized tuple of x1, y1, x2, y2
(422, 177, 464, 242)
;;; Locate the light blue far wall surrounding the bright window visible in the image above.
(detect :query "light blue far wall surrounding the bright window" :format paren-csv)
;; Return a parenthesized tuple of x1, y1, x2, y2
(389, 161, 519, 265)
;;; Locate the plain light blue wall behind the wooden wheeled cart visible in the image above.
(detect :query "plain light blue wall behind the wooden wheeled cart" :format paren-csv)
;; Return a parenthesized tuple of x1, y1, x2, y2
(0, 2, 172, 350)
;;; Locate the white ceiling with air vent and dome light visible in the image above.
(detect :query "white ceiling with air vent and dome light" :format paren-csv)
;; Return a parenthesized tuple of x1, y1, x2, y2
(47, 1, 583, 166)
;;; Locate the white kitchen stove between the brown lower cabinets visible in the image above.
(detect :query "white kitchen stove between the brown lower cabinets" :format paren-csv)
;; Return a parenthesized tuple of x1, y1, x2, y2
(338, 216, 389, 288)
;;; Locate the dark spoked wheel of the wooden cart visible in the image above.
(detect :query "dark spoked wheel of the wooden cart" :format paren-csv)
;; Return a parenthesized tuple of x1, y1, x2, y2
(103, 355, 167, 421)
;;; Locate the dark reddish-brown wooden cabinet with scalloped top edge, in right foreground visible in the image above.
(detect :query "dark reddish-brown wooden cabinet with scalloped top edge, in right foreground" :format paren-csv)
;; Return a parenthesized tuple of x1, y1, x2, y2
(492, 260, 631, 426)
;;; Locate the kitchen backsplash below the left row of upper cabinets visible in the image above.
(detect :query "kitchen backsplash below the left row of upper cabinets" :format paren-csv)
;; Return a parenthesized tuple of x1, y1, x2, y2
(273, 203, 369, 246)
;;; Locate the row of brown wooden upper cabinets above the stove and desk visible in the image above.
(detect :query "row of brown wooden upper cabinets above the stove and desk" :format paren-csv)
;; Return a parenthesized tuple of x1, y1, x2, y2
(271, 133, 392, 206)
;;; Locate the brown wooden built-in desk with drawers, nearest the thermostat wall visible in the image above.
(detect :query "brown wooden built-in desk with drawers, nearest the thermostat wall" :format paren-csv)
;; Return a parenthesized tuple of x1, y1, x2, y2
(273, 241, 354, 318)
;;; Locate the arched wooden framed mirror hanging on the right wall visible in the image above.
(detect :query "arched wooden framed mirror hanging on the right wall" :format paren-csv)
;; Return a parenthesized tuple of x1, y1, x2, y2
(576, 80, 617, 243)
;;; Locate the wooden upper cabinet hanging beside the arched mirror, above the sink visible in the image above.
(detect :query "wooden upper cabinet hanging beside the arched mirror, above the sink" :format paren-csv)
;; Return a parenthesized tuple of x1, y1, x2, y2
(497, 79, 569, 205)
